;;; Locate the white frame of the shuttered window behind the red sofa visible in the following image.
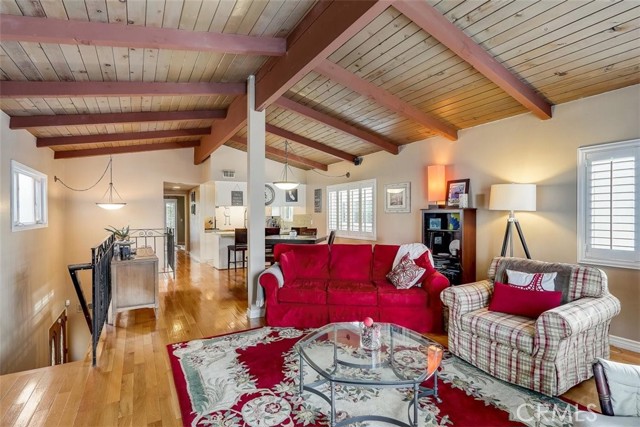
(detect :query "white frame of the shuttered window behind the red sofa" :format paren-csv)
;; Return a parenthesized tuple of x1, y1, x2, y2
(327, 179, 377, 240)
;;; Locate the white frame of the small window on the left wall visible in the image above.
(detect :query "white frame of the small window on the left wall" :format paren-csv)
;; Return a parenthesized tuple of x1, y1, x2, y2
(11, 160, 49, 231)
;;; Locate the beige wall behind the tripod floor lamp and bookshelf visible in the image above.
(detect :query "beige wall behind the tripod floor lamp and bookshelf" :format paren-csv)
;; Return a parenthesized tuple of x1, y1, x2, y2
(307, 85, 640, 341)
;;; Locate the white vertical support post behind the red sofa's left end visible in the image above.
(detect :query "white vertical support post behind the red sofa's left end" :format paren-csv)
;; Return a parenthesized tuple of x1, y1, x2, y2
(247, 76, 266, 319)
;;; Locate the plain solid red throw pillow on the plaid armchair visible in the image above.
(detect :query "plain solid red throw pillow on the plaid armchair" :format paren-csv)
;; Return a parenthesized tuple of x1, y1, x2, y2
(489, 282, 562, 319)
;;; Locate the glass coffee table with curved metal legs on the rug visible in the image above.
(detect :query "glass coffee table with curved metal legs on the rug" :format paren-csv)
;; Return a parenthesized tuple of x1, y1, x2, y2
(295, 322, 442, 427)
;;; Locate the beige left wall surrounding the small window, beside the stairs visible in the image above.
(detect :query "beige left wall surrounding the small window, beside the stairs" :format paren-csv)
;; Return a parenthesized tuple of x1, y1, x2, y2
(0, 112, 74, 374)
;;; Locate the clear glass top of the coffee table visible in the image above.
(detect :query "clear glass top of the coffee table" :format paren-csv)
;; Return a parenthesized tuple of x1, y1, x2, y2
(296, 322, 438, 385)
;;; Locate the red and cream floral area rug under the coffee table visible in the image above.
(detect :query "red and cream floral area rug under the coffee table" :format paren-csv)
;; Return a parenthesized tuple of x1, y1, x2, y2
(167, 327, 575, 427)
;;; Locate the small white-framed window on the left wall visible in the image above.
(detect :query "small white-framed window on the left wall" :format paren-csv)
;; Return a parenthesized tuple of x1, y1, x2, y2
(11, 160, 47, 231)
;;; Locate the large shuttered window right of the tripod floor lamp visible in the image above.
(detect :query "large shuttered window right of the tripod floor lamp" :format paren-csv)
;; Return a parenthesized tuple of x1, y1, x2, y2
(578, 139, 640, 269)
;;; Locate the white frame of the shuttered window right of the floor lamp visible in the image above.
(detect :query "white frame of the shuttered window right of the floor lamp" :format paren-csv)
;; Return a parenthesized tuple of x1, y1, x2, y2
(578, 139, 640, 270)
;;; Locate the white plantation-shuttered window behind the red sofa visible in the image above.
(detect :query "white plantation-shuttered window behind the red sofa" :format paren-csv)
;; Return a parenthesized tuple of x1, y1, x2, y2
(327, 179, 376, 240)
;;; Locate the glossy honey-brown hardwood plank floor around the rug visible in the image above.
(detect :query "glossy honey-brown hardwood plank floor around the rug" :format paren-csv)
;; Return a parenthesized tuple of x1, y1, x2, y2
(0, 252, 640, 427)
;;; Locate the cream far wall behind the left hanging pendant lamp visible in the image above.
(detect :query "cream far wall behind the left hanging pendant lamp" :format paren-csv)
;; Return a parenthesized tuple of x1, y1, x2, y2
(56, 149, 202, 359)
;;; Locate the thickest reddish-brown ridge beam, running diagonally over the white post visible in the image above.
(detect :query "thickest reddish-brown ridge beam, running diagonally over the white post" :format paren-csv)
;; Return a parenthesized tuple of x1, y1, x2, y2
(193, 0, 391, 164)
